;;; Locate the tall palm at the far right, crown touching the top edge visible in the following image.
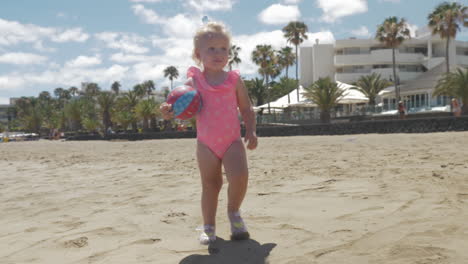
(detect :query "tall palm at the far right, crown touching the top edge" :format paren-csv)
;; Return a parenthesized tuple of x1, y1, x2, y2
(427, 2, 468, 72)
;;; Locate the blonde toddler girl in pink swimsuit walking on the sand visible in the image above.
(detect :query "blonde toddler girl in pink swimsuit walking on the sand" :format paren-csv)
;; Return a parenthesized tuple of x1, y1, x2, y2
(161, 22, 257, 244)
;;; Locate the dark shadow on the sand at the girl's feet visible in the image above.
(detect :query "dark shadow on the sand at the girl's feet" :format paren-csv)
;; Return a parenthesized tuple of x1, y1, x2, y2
(179, 237, 276, 264)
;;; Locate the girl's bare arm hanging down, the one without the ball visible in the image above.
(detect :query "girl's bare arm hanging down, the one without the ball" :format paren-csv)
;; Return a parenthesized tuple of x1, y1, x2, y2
(236, 78, 257, 149)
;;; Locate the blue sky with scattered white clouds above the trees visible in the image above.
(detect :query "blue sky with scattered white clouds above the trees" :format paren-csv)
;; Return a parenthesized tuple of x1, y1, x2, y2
(0, 0, 468, 104)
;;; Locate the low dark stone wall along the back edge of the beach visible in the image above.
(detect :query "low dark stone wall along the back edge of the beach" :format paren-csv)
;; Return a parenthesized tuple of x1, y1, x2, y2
(67, 116, 468, 140)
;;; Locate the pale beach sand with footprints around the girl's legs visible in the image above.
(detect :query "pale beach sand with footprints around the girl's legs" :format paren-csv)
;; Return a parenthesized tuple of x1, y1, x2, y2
(0, 132, 468, 264)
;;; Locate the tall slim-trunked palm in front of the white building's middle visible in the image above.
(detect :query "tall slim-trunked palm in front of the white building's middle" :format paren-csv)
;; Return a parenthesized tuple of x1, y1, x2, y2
(375, 16, 410, 103)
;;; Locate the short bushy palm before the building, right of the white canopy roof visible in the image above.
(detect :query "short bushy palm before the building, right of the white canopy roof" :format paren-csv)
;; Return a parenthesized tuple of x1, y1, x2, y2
(351, 72, 392, 106)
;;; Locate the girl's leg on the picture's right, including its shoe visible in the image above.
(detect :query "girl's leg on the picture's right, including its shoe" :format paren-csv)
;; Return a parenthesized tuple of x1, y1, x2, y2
(223, 140, 249, 240)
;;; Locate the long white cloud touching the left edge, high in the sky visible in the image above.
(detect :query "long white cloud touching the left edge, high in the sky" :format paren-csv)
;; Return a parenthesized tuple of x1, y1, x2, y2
(0, 18, 89, 46)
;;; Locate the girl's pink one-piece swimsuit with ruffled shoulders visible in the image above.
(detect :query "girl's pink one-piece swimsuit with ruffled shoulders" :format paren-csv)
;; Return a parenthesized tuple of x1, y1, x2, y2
(187, 67, 241, 159)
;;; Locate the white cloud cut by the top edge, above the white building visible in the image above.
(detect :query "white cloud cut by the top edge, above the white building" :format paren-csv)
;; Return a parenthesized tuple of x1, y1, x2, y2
(317, 0, 367, 22)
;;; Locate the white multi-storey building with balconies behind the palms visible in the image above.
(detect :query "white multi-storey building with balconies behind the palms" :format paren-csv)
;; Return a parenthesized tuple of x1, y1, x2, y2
(300, 30, 468, 109)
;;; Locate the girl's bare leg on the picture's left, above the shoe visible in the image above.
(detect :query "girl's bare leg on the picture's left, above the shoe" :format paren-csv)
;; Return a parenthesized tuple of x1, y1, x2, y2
(197, 142, 223, 226)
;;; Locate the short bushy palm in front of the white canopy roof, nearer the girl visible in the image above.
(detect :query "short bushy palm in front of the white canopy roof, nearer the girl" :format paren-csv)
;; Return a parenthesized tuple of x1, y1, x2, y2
(303, 77, 344, 123)
